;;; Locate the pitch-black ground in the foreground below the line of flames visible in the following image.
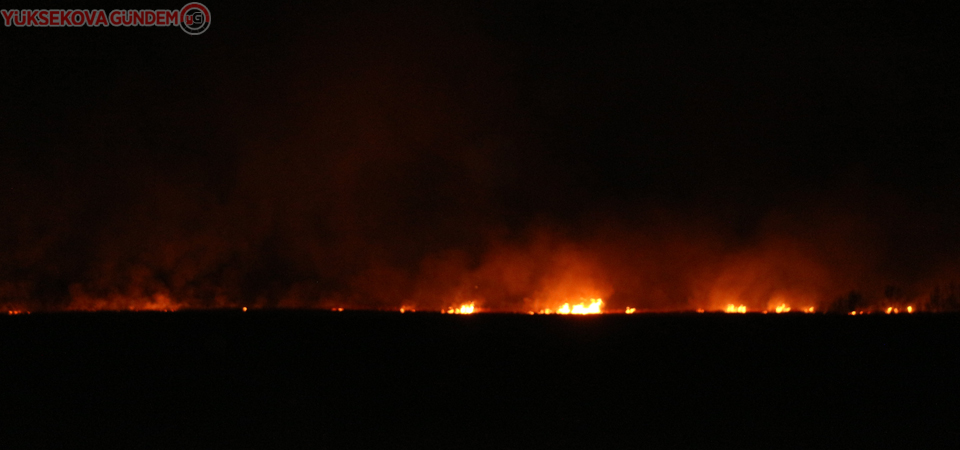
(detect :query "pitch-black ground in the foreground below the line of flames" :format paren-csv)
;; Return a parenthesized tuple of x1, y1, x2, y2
(0, 311, 960, 449)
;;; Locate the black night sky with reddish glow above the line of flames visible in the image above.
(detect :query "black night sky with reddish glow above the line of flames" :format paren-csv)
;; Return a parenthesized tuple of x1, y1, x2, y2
(0, 1, 960, 309)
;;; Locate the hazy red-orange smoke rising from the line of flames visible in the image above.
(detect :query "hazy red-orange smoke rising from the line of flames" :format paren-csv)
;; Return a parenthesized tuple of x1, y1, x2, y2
(0, 6, 960, 311)
